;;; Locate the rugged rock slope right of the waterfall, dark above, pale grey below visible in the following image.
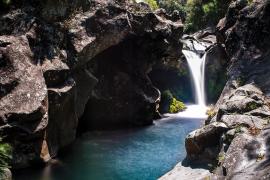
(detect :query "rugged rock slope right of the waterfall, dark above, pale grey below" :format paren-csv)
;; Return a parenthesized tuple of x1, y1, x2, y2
(179, 0, 270, 179)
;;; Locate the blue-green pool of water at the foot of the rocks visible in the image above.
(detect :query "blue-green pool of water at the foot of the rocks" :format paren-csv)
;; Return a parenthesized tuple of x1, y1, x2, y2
(14, 116, 202, 180)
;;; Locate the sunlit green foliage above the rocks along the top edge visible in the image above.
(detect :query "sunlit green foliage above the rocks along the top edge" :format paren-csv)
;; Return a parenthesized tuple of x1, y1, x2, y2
(139, 0, 232, 32)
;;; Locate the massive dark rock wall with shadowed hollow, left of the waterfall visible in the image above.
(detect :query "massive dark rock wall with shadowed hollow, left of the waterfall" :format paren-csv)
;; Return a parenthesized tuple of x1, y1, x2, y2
(0, 0, 182, 168)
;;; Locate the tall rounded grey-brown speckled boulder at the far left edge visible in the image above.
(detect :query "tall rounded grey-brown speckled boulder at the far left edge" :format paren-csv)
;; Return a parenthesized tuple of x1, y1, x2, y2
(0, 36, 48, 168)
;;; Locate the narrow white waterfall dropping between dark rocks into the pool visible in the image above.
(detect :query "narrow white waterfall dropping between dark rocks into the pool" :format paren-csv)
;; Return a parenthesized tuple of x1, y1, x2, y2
(182, 50, 206, 106)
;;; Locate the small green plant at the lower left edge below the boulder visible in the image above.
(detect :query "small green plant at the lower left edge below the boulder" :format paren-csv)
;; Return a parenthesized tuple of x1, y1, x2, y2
(0, 139, 11, 176)
